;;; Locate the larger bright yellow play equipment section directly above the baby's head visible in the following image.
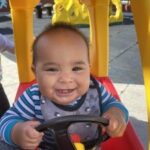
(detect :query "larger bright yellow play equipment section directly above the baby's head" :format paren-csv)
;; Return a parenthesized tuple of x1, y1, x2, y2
(52, 0, 89, 24)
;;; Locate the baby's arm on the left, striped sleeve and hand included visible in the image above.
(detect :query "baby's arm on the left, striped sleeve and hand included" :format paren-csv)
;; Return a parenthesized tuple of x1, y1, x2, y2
(0, 88, 42, 147)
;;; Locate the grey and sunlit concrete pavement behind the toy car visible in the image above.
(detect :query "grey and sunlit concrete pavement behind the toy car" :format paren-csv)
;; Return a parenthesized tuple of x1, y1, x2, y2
(0, 13, 148, 150)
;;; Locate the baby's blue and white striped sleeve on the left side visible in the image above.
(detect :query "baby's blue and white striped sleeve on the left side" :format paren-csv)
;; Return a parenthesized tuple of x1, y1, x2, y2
(0, 89, 35, 145)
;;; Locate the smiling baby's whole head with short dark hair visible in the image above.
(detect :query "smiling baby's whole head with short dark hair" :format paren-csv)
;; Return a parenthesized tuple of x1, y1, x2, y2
(33, 23, 90, 105)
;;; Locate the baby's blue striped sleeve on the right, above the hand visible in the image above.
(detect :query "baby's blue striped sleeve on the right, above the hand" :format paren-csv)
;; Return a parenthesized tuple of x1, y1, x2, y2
(99, 83, 129, 122)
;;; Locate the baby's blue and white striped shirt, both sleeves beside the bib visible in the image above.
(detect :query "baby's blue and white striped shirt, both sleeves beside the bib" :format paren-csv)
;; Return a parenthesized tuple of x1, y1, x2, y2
(0, 82, 128, 145)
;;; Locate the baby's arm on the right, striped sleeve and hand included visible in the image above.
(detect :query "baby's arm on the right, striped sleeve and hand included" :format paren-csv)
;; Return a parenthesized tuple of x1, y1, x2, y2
(99, 84, 128, 137)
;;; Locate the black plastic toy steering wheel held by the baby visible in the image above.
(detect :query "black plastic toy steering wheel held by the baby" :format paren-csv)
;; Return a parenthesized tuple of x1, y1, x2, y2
(36, 115, 109, 150)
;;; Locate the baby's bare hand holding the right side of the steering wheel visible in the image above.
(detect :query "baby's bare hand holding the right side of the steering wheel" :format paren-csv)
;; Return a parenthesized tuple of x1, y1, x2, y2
(102, 107, 127, 137)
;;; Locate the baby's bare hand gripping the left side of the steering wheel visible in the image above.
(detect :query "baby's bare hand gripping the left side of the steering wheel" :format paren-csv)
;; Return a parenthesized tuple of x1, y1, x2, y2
(12, 121, 43, 150)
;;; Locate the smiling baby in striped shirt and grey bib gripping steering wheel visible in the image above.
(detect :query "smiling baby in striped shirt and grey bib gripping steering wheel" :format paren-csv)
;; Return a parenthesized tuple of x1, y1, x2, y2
(0, 23, 128, 149)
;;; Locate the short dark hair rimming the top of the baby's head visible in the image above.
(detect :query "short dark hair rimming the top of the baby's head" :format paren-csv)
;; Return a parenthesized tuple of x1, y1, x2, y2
(32, 22, 89, 65)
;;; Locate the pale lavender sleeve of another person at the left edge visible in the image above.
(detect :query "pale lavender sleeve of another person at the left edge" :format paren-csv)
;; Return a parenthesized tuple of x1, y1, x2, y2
(0, 34, 14, 53)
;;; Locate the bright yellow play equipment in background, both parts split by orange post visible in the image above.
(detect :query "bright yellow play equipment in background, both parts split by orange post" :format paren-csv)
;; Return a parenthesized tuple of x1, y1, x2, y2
(52, 0, 123, 25)
